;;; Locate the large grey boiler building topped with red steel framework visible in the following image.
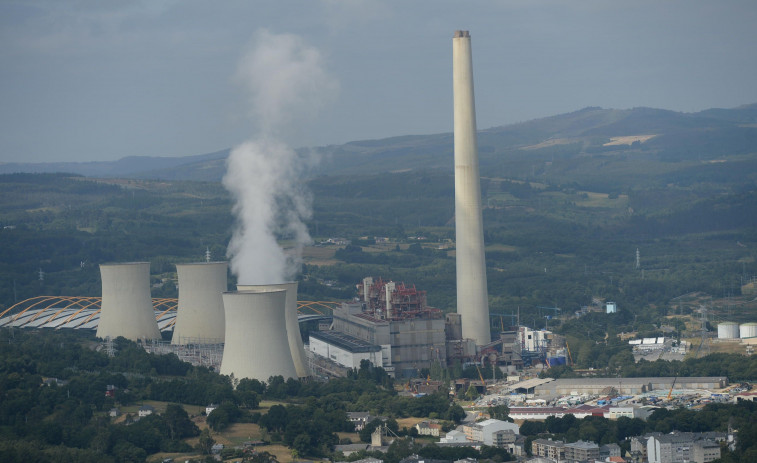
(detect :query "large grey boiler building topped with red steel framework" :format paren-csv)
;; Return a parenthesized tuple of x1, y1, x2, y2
(310, 277, 447, 377)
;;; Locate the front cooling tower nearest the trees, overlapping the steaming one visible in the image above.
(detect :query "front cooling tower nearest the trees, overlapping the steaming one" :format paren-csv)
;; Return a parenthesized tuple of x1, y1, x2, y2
(221, 289, 297, 381)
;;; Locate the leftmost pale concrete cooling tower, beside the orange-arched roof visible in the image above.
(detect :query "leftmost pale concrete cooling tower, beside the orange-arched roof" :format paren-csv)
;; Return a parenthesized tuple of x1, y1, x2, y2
(97, 262, 160, 341)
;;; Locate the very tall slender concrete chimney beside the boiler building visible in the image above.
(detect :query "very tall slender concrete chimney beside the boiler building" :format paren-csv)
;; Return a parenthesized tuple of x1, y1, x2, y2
(452, 31, 491, 346)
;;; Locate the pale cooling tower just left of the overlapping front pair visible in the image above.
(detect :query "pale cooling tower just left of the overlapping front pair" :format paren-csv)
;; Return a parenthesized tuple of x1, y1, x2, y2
(171, 262, 228, 344)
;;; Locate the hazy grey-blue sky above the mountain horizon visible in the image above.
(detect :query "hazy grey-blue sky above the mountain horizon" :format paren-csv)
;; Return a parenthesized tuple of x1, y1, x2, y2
(0, 0, 757, 162)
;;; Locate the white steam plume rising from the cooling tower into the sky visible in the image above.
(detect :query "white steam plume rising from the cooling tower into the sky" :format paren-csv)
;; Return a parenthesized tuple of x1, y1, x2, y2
(223, 31, 337, 285)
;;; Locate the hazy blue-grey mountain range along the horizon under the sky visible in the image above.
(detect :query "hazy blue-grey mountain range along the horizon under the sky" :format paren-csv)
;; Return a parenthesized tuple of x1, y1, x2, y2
(0, 104, 757, 185)
